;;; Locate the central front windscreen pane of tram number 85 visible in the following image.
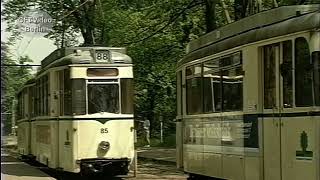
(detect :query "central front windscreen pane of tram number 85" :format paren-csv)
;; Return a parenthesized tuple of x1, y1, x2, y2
(88, 84, 119, 114)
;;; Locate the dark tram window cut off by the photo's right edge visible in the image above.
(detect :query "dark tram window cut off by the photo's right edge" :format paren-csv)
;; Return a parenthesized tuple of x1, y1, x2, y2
(312, 51, 320, 106)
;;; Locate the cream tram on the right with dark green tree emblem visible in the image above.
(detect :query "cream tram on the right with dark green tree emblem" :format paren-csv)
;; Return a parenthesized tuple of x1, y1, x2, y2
(177, 4, 320, 180)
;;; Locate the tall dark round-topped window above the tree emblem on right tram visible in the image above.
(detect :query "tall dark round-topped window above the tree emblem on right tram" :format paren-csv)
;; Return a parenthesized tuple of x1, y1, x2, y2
(295, 37, 313, 107)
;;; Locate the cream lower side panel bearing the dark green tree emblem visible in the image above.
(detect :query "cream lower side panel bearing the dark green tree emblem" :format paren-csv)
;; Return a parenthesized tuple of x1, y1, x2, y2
(281, 116, 320, 180)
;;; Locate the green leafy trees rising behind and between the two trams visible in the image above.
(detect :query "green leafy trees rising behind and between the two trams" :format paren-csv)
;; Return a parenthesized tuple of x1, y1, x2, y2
(2, 0, 304, 141)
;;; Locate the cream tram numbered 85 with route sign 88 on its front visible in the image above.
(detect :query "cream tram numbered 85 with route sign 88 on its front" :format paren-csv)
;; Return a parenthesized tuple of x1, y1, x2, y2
(17, 47, 134, 175)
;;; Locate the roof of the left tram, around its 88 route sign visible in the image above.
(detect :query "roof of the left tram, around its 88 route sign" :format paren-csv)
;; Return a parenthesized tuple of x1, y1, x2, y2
(41, 47, 132, 71)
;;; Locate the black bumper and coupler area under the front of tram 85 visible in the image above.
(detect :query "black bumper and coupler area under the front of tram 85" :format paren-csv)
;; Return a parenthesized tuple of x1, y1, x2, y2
(80, 158, 130, 176)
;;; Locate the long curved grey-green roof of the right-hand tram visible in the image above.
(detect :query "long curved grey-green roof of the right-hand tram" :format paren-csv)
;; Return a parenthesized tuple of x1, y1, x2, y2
(178, 4, 320, 66)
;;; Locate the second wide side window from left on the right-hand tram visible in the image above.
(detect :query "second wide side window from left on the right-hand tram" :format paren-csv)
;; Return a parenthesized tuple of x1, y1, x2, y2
(203, 59, 222, 113)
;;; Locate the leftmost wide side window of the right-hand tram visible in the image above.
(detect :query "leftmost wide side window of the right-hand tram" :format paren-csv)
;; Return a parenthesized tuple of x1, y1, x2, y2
(186, 64, 202, 114)
